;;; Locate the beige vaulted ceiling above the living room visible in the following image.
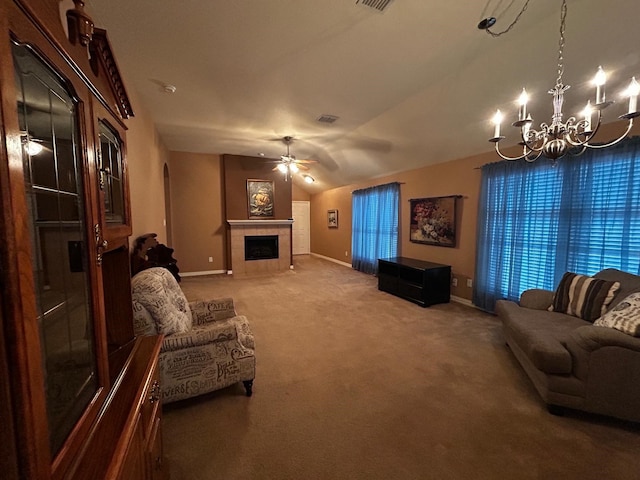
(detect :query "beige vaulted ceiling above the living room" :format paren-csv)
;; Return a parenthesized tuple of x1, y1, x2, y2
(87, 0, 640, 193)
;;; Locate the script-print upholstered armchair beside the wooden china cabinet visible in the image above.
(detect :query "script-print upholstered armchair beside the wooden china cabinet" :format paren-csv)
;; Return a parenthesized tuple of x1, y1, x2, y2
(131, 267, 256, 403)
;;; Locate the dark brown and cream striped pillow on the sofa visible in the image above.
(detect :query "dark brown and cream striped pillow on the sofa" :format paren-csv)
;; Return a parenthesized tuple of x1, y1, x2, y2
(549, 272, 620, 322)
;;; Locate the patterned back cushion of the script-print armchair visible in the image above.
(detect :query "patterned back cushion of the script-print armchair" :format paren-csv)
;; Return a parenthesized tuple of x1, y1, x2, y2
(131, 267, 192, 335)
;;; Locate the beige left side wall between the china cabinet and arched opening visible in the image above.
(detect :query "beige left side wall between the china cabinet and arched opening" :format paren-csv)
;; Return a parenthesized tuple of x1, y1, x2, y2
(126, 91, 169, 246)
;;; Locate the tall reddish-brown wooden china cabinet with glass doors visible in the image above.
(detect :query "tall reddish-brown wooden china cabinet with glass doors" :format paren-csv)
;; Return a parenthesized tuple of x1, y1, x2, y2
(0, 0, 162, 480)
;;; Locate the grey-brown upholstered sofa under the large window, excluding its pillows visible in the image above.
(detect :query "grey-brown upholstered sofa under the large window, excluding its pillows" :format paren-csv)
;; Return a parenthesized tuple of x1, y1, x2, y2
(496, 269, 640, 422)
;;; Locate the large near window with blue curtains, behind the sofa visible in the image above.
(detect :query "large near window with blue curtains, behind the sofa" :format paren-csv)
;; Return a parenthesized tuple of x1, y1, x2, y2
(473, 138, 640, 311)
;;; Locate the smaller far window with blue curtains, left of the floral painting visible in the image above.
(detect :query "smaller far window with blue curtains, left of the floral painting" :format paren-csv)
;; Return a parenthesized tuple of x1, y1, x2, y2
(351, 183, 400, 273)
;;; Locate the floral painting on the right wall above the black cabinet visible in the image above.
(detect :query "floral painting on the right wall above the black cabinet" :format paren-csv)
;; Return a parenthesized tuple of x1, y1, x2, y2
(409, 195, 458, 247)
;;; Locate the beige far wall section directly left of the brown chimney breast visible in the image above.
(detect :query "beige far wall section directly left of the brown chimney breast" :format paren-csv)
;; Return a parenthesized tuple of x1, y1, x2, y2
(169, 152, 227, 273)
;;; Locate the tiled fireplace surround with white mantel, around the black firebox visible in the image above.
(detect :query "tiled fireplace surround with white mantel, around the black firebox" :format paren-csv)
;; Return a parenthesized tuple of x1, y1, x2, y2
(227, 220, 293, 276)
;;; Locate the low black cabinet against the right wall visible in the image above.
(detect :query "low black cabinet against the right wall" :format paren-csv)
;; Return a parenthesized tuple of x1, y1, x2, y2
(378, 257, 451, 307)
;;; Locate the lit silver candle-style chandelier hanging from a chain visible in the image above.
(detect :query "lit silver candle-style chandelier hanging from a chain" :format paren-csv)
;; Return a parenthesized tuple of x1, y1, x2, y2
(478, 0, 640, 162)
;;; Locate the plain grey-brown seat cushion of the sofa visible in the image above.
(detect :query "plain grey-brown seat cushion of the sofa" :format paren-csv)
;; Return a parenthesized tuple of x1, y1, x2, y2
(496, 300, 590, 374)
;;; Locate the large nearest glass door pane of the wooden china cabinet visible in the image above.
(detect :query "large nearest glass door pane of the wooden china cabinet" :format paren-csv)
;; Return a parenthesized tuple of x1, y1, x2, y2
(12, 40, 98, 455)
